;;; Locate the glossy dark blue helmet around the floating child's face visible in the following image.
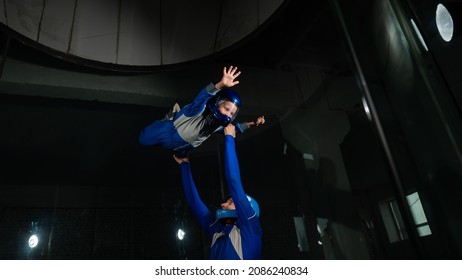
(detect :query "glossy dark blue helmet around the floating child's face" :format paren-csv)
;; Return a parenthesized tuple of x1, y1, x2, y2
(207, 88, 242, 126)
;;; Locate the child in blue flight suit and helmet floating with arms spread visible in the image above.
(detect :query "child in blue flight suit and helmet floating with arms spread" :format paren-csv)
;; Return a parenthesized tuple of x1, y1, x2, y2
(139, 66, 265, 158)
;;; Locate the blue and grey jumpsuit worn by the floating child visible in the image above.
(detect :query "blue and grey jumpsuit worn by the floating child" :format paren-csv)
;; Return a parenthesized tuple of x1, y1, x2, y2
(139, 83, 248, 157)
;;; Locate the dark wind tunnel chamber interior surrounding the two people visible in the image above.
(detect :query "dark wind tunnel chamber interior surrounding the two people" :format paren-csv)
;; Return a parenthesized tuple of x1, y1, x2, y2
(0, 0, 462, 260)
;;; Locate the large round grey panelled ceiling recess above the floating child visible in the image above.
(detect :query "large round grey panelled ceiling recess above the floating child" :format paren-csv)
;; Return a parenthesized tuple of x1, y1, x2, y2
(0, 0, 283, 67)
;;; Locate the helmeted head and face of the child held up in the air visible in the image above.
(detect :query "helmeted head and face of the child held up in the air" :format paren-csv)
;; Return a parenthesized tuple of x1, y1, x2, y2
(207, 88, 241, 126)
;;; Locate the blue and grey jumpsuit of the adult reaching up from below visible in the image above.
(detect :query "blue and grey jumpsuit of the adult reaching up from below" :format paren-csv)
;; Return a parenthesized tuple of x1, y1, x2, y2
(181, 135, 262, 260)
